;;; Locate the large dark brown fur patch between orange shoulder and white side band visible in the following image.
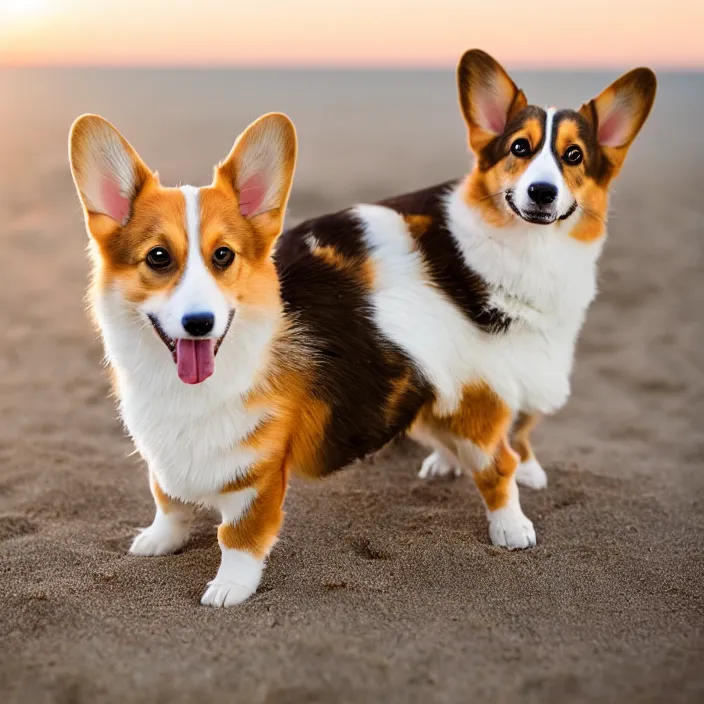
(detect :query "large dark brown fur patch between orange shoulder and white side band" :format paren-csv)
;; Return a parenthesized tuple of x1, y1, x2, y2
(276, 210, 432, 476)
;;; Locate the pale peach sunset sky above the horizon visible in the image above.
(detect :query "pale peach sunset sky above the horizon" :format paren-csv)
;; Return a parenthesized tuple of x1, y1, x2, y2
(0, 0, 704, 69)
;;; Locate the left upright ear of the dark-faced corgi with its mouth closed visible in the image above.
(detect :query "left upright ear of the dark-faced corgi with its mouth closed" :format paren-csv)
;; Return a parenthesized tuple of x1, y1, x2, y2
(457, 49, 528, 154)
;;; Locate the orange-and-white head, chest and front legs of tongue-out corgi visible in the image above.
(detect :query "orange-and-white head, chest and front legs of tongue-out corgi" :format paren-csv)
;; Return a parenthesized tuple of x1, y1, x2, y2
(69, 113, 304, 606)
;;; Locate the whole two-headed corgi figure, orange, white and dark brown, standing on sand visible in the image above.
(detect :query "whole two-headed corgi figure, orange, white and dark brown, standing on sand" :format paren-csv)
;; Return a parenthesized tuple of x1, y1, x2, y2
(69, 50, 655, 607)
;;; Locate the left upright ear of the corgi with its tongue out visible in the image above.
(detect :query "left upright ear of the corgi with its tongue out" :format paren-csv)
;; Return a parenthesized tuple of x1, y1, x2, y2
(68, 115, 155, 236)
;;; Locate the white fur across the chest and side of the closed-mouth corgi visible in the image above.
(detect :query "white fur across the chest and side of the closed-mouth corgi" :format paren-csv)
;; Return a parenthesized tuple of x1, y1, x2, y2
(356, 191, 601, 413)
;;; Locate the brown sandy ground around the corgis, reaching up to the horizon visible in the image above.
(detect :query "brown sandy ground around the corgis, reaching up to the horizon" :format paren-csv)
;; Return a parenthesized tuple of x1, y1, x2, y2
(0, 67, 704, 704)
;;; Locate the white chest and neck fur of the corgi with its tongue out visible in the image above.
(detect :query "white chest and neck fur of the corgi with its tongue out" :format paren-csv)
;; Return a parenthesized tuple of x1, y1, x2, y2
(94, 292, 275, 501)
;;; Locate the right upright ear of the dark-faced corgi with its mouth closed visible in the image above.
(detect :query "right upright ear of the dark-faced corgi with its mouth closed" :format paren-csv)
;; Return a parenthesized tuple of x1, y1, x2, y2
(579, 68, 657, 178)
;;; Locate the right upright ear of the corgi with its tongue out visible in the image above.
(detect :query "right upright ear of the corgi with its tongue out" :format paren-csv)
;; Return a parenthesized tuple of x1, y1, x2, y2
(215, 113, 297, 250)
